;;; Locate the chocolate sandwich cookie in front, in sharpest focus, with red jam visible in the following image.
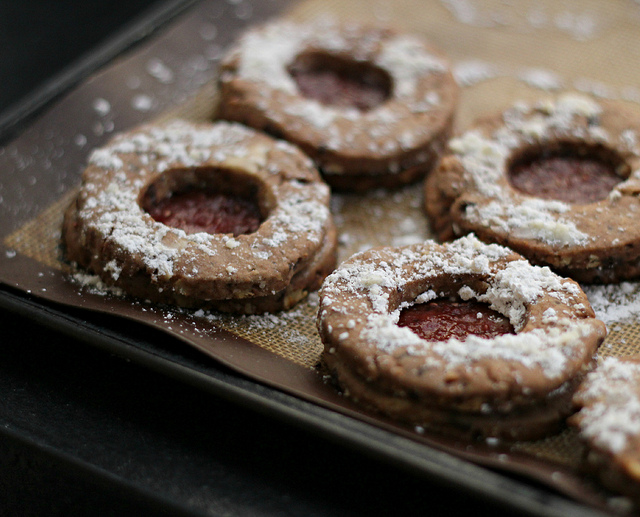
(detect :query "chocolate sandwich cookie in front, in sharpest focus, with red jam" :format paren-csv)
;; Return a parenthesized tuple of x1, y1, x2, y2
(318, 235, 606, 440)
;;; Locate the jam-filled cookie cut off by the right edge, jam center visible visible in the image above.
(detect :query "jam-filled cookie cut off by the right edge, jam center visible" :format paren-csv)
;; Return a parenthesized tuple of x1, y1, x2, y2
(425, 94, 640, 283)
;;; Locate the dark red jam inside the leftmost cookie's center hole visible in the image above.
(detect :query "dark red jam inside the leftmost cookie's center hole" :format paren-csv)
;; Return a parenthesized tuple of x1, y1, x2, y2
(148, 190, 262, 236)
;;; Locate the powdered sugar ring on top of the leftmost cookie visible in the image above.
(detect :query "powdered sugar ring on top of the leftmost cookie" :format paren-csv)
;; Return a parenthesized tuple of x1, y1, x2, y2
(78, 121, 331, 290)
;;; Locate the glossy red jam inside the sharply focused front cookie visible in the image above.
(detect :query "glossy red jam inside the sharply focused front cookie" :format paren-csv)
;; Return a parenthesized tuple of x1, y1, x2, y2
(398, 299, 514, 341)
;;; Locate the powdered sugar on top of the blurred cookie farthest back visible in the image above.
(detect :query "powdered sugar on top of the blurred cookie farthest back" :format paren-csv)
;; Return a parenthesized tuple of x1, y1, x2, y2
(221, 18, 454, 158)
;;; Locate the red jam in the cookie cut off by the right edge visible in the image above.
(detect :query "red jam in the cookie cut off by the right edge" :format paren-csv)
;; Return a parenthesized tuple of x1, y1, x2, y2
(509, 154, 621, 204)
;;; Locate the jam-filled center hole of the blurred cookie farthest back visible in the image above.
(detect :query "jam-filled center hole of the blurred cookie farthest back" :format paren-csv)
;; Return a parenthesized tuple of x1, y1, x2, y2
(288, 53, 391, 111)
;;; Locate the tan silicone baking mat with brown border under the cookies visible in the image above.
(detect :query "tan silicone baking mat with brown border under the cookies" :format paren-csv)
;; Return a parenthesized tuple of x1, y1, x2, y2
(0, 0, 640, 510)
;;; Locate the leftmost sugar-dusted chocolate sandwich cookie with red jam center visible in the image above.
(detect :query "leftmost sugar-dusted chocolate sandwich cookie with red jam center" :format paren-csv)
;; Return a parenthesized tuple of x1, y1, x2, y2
(63, 121, 336, 313)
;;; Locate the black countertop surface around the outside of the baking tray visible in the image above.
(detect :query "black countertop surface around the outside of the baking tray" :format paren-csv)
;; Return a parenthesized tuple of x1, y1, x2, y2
(0, 0, 568, 516)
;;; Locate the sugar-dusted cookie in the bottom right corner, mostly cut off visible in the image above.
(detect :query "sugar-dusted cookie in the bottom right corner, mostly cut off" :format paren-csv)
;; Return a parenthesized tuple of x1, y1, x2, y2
(569, 356, 640, 505)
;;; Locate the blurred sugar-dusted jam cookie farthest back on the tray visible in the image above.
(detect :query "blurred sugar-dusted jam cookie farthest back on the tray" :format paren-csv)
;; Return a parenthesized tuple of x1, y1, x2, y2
(218, 20, 458, 190)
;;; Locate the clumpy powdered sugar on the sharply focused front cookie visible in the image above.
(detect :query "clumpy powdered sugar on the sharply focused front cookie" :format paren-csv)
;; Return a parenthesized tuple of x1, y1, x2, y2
(321, 235, 591, 378)
